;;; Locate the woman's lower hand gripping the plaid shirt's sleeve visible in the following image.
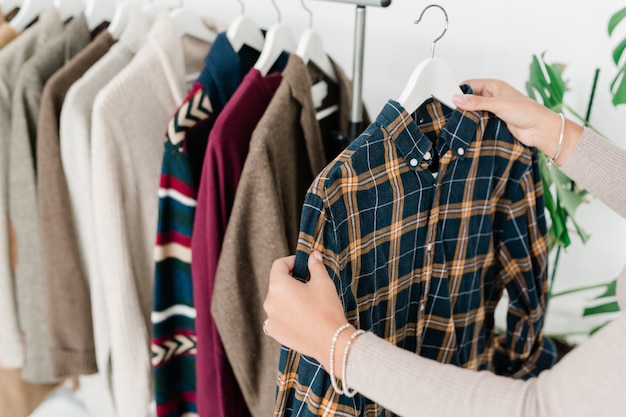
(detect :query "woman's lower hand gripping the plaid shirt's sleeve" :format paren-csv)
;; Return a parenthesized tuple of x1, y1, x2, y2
(263, 251, 354, 370)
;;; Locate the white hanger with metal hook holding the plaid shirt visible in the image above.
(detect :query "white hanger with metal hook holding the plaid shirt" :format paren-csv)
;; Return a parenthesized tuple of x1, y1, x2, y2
(398, 4, 463, 113)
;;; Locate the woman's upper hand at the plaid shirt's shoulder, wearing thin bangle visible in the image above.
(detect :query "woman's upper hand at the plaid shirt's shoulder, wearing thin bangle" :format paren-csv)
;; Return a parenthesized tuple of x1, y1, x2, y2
(454, 80, 583, 165)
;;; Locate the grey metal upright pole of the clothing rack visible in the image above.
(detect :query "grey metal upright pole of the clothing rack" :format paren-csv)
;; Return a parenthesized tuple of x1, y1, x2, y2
(312, 0, 391, 142)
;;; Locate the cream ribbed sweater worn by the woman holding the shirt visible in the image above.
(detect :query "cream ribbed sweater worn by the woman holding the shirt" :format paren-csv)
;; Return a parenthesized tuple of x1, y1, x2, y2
(346, 129, 626, 417)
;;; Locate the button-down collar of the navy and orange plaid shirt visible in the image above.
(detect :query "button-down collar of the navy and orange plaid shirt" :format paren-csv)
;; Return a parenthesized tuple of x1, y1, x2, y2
(377, 85, 480, 169)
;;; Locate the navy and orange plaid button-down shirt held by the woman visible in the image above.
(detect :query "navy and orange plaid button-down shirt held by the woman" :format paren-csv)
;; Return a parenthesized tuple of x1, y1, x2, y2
(276, 94, 555, 416)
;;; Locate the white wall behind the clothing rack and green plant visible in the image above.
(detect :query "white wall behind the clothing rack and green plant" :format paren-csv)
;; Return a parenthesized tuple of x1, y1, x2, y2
(160, 0, 626, 331)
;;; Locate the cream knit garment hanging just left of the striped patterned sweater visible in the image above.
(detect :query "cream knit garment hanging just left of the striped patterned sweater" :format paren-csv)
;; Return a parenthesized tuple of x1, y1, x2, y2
(91, 12, 217, 416)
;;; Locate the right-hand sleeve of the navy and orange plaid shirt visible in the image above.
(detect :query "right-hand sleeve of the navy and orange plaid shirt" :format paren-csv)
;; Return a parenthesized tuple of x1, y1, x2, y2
(493, 148, 556, 379)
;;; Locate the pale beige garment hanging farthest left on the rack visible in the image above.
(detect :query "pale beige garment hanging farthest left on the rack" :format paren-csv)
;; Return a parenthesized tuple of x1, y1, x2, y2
(0, 8, 63, 368)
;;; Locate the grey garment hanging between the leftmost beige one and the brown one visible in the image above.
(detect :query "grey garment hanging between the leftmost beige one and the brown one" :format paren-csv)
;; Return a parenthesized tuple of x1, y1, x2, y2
(9, 10, 91, 383)
